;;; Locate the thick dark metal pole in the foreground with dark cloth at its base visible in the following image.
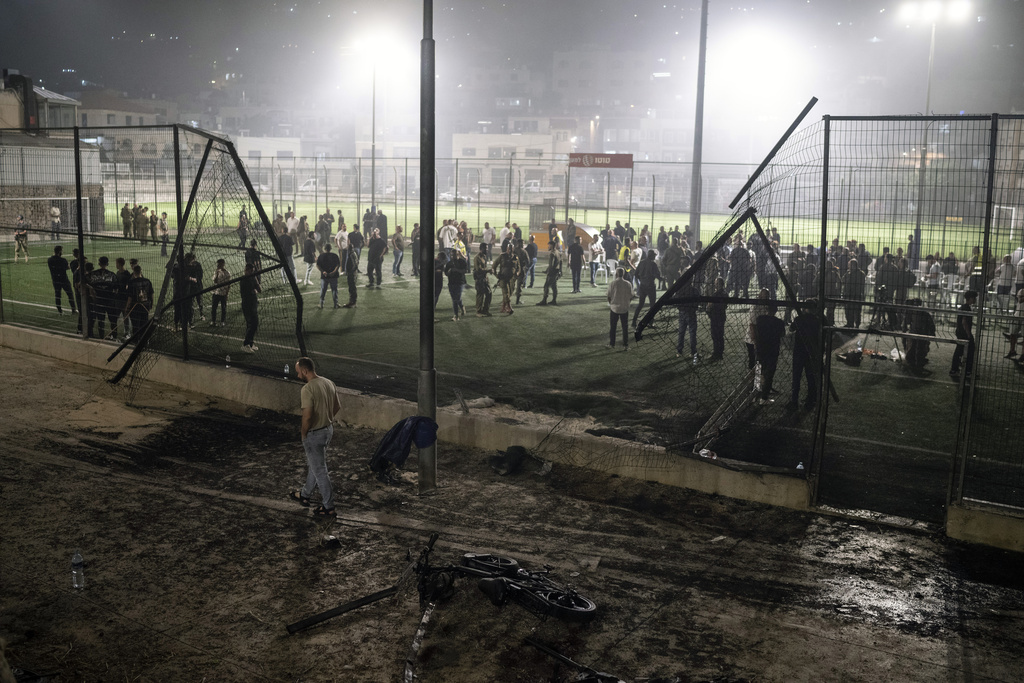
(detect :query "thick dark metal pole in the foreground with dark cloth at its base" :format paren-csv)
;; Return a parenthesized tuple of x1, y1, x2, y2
(417, 0, 437, 494)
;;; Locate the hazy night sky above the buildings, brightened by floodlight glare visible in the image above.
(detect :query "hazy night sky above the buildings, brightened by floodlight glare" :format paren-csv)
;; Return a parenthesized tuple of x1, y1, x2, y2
(0, 0, 1024, 114)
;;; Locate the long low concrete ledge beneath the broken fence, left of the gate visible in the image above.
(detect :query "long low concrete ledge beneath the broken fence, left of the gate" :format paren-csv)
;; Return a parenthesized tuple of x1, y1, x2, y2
(0, 325, 809, 510)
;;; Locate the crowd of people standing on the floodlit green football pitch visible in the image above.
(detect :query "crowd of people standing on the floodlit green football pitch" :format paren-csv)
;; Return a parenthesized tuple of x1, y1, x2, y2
(29, 197, 1024, 385)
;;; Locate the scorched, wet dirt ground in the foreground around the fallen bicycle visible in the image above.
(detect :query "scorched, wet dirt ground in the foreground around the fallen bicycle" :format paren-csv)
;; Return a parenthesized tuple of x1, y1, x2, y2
(0, 349, 1024, 683)
